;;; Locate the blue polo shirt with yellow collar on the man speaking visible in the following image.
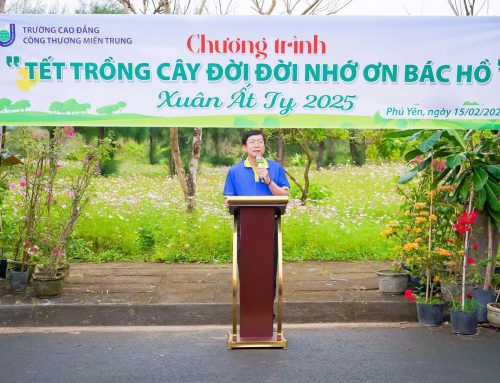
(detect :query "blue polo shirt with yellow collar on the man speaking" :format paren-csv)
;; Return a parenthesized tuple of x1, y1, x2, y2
(222, 160, 290, 196)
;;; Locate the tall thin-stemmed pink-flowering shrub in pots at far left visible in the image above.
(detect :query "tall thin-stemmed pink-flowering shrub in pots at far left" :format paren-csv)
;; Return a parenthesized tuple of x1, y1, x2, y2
(10, 127, 111, 276)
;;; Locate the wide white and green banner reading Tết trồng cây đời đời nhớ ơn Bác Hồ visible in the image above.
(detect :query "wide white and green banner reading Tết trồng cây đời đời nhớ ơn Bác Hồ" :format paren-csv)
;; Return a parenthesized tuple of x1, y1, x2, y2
(0, 15, 500, 129)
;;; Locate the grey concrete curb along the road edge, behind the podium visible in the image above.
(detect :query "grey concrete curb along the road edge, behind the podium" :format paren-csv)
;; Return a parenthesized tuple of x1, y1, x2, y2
(0, 301, 417, 327)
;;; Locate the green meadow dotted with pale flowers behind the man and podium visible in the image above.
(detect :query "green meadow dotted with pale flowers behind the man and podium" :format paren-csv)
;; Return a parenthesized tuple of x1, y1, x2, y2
(1, 139, 401, 263)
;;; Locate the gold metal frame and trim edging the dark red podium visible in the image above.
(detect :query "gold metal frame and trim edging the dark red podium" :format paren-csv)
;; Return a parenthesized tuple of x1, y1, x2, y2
(227, 196, 288, 350)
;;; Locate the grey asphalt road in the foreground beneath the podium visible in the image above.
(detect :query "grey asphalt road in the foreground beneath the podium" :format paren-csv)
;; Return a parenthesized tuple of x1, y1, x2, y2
(0, 324, 500, 383)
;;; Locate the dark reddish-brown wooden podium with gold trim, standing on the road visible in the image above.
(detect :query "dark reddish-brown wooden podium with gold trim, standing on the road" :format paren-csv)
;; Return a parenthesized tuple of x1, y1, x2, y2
(227, 196, 288, 349)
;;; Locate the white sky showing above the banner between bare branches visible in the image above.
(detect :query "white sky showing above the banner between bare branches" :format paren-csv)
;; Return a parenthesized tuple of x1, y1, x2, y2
(24, 0, 500, 16)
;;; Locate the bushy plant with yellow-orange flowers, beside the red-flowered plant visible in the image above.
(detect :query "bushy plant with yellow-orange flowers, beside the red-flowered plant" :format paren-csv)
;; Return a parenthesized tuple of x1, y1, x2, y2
(381, 162, 459, 303)
